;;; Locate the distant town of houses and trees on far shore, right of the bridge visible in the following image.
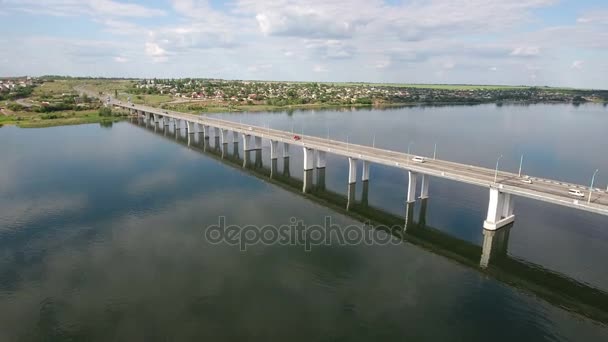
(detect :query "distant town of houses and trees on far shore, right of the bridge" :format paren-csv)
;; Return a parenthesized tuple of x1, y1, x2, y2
(128, 79, 608, 106)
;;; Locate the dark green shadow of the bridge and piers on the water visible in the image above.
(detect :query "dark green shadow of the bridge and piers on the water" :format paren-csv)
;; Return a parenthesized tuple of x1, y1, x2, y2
(131, 119, 608, 324)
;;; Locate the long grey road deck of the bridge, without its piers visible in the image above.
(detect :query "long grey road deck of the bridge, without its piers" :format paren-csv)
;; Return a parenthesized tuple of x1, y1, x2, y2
(112, 101, 608, 215)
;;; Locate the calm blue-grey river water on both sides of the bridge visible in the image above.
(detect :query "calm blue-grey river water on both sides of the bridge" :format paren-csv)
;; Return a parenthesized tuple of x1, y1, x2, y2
(0, 105, 608, 341)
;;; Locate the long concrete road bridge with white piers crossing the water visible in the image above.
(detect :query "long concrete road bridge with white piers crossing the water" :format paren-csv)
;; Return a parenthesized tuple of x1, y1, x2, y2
(108, 99, 608, 230)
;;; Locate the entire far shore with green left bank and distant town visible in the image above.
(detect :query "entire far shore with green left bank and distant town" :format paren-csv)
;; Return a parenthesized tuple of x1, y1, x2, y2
(0, 76, 608, 127)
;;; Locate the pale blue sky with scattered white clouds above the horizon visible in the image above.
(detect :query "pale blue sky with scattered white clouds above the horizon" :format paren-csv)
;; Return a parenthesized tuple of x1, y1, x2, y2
(0, 0, 608, 89)
